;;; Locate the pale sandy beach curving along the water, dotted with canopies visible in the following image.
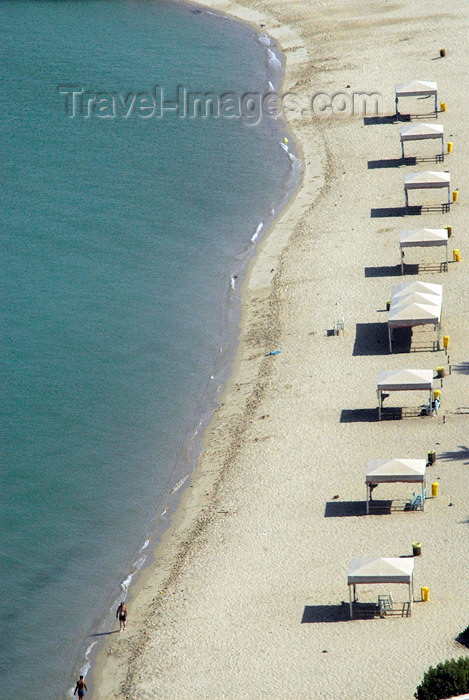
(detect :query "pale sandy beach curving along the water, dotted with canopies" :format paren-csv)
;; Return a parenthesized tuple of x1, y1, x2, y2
(92, 0, 469, 700)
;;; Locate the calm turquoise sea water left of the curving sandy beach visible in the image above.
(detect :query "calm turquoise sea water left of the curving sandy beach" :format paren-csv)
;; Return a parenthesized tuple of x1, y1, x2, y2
(0, 0, 297, 700)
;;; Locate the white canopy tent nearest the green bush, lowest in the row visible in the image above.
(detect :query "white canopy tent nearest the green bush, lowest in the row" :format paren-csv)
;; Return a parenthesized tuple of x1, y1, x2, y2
(347, 557, 414, 619)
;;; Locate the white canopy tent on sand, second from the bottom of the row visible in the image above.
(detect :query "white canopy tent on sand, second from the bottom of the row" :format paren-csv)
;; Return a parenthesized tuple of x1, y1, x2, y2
(365, 458, 427, 514)
